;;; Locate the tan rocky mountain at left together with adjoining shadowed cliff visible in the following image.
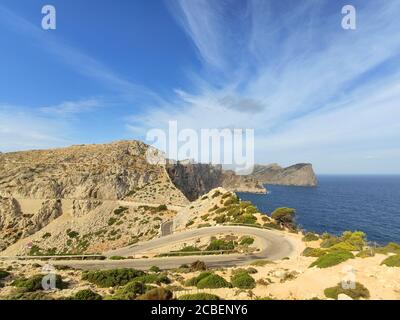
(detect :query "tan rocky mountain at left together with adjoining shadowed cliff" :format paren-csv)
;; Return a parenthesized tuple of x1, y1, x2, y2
(0, 141, 265, 254)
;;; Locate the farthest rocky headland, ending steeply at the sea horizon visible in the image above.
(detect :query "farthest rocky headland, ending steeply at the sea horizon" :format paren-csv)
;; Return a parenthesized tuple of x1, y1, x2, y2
(250, 163, 318, 187)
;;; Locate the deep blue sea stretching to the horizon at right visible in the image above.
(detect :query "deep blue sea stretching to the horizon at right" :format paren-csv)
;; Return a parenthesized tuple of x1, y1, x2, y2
(239, 175, 400, 244)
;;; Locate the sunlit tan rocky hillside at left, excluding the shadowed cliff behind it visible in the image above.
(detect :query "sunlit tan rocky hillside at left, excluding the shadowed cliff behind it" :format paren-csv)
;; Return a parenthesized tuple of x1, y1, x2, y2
(0, 141, 189, 253)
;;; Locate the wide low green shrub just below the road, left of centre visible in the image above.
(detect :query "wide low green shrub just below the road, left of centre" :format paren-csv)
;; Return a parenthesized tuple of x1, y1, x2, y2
(82, 269, 145, 288)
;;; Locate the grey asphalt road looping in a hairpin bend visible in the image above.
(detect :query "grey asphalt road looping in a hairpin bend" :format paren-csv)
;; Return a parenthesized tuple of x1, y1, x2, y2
(51, 226, 294, 270)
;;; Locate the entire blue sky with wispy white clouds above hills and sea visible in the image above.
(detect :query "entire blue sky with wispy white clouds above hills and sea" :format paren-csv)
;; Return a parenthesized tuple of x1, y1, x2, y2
(0, 0, 400, 174)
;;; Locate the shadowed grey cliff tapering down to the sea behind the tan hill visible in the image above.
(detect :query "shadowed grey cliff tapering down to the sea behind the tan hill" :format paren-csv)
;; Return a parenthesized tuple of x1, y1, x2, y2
(166, 162, 266, 201)
